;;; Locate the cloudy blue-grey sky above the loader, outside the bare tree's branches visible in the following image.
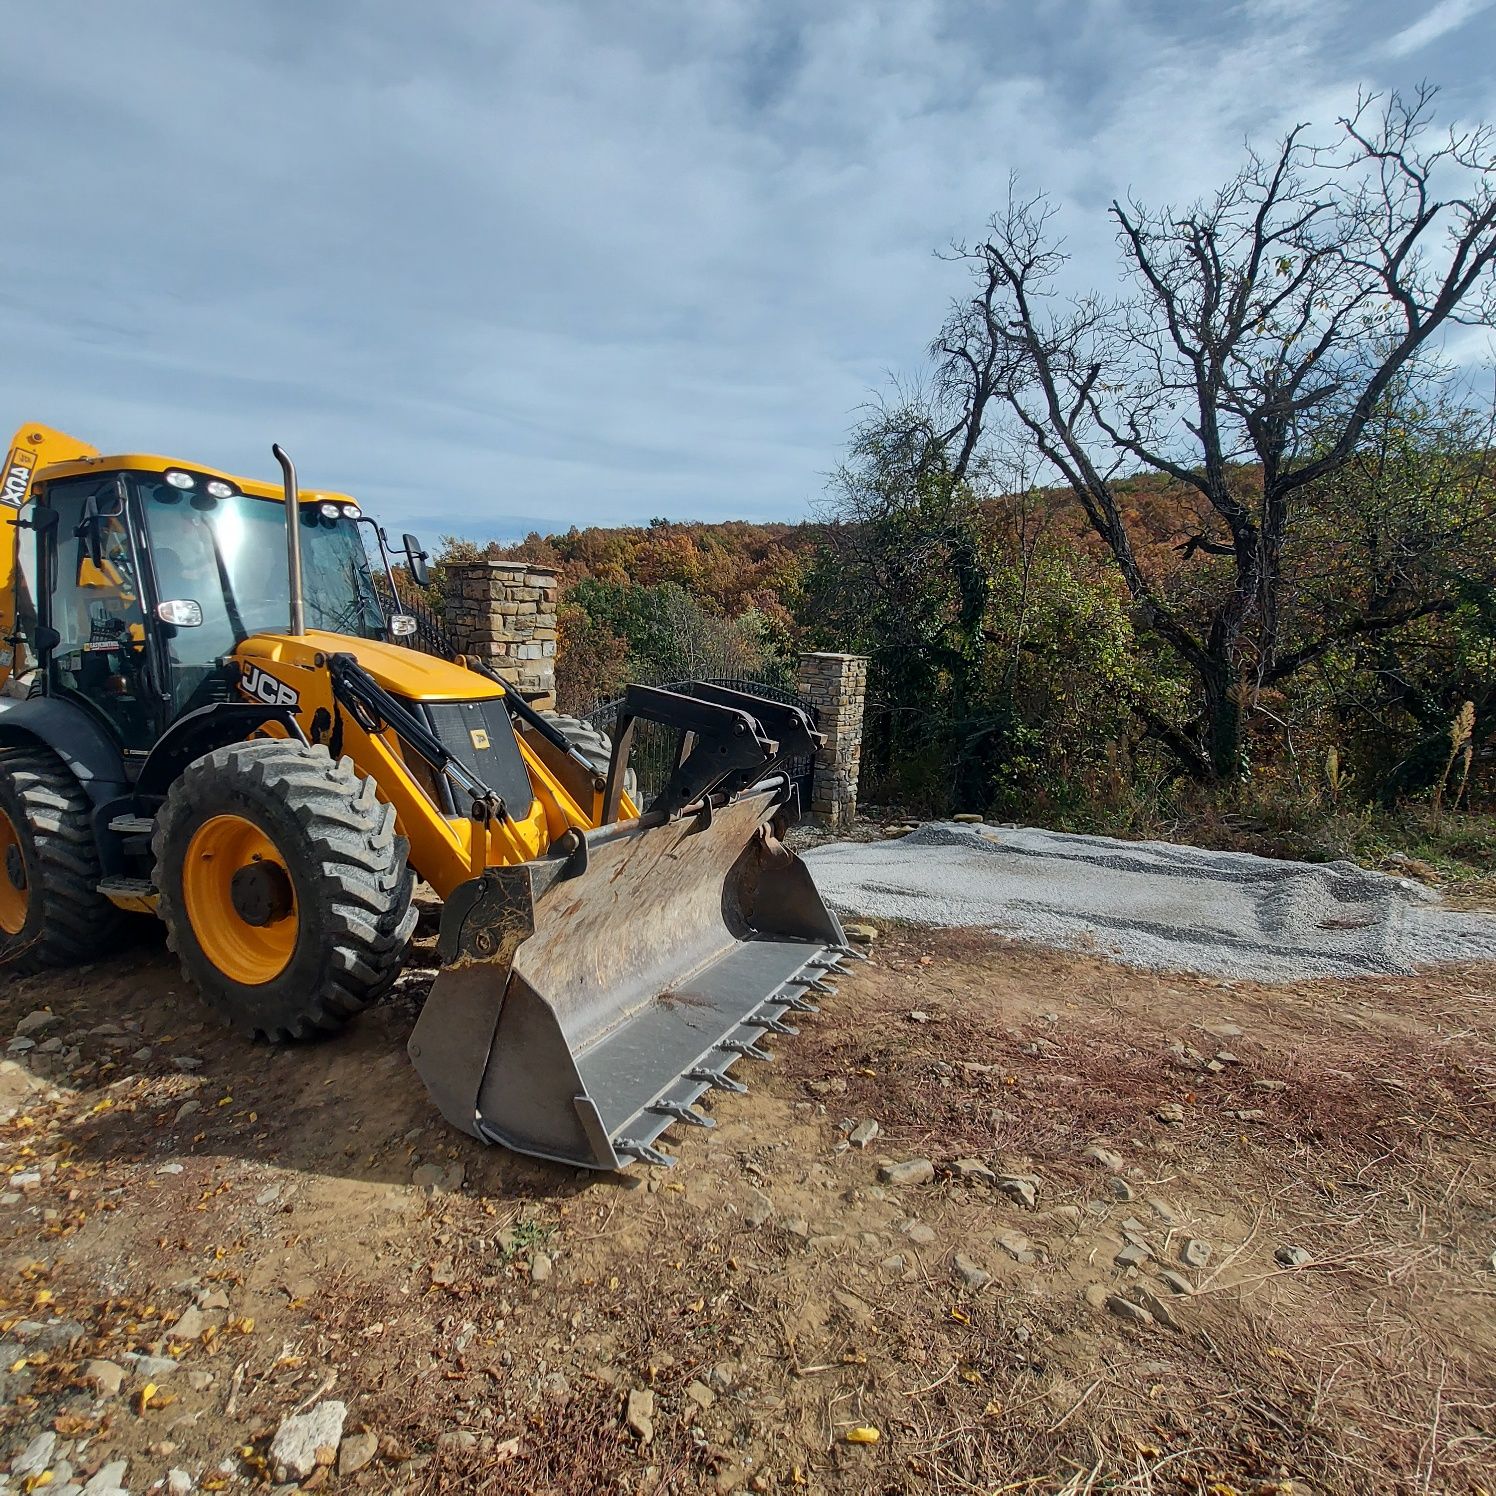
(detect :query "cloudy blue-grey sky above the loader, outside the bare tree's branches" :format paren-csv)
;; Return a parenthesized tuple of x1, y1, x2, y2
(0, 0, 1496, 539)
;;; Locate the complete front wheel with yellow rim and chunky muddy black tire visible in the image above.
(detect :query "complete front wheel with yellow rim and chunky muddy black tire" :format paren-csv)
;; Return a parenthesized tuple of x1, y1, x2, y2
(151, 738, 416, 1041)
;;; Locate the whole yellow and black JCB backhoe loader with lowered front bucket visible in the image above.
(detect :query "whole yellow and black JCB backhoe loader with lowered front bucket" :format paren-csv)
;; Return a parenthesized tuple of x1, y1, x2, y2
(0, 426, 851, 1168)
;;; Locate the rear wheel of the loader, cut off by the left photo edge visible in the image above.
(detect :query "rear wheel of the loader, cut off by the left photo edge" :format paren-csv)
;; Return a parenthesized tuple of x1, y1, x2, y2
(0, 748, 121, 971)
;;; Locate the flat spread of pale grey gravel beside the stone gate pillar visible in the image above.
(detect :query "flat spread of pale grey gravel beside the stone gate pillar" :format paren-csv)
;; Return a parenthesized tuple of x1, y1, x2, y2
(803, 823, 1496, 981)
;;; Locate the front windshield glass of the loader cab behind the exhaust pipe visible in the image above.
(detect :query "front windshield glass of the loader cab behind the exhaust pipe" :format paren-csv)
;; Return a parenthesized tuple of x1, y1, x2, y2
(132, 473, 384, 711)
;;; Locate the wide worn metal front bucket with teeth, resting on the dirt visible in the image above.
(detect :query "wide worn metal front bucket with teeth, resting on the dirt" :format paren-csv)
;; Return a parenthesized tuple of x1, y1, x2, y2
(410, 785, 847, 1168)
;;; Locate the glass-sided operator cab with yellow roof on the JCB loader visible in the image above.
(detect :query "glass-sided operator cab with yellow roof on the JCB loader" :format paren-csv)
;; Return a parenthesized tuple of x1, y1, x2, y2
(21, 456, 403, 757)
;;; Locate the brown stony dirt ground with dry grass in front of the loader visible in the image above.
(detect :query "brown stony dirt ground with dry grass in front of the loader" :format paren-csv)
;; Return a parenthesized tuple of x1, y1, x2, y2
(0, 929, 1496, 1496)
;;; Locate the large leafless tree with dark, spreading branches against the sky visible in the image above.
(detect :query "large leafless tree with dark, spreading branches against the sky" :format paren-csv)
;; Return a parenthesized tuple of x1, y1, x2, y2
(932, 88, 1496, 778)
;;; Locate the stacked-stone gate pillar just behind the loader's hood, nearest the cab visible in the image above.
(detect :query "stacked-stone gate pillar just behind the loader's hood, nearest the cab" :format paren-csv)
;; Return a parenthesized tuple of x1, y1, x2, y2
(443, 561, 557, 706)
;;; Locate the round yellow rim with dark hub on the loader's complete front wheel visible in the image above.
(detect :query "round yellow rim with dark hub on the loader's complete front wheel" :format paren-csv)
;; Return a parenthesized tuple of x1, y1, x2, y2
(183, 815, 301, 987)
